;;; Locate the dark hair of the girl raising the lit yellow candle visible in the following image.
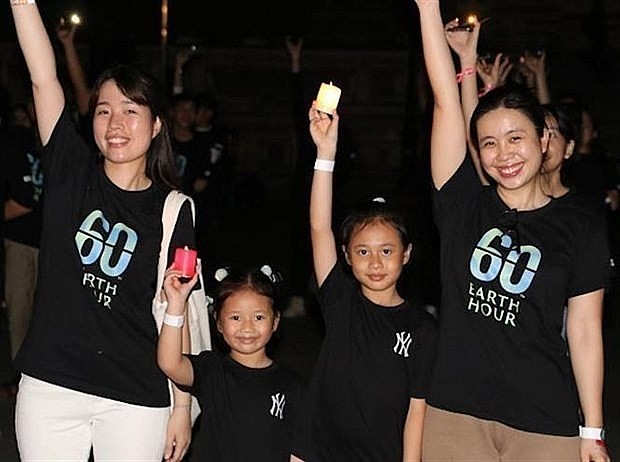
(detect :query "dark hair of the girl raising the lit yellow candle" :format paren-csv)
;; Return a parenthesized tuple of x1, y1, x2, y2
(339, 199, 411, 247)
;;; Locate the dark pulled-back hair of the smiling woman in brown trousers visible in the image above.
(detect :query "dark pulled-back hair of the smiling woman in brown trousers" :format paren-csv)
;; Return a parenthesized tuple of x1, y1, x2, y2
(469, 83, 545, 151)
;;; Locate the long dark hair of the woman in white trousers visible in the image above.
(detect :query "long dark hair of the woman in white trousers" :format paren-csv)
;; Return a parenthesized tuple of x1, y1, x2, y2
(89, 64, 179, 189)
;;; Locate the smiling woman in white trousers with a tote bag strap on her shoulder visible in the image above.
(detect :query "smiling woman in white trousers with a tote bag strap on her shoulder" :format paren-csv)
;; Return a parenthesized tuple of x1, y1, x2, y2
(12, 3, 200, 462)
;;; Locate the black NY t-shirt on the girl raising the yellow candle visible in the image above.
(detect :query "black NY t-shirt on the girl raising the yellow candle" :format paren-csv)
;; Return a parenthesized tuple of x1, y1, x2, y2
(293, 263, 436, 462)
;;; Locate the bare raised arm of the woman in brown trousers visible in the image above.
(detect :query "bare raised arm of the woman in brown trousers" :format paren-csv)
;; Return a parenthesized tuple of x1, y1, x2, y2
(416, 0, 466, 189)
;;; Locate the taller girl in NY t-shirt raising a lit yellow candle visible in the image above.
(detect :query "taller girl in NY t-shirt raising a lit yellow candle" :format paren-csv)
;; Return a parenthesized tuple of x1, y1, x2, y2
(293, 102, 435, 462)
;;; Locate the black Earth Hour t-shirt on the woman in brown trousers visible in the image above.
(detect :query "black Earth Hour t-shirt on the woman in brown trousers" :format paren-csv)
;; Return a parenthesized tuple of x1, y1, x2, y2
(427, 160, 609, 436)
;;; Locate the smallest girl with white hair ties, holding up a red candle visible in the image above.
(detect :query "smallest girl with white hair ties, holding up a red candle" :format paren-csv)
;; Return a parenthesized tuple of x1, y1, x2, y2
(157, 265, 302, 462)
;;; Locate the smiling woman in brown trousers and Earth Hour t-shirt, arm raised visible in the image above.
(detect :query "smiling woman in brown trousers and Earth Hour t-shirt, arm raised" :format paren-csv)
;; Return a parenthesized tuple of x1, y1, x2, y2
(416, 0, 609, 462)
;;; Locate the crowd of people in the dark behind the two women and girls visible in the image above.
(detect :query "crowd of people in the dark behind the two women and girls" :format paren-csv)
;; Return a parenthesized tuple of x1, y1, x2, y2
(0, 1, 620, 460)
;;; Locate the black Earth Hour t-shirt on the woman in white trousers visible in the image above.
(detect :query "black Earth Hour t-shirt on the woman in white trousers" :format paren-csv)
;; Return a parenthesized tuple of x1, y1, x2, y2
(16, 110, 194, 407)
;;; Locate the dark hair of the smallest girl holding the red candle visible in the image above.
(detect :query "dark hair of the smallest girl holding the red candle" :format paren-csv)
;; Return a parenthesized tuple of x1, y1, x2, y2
(213, 268, 280, 315)
